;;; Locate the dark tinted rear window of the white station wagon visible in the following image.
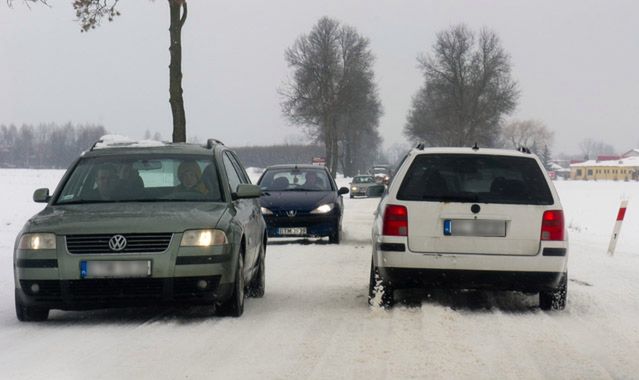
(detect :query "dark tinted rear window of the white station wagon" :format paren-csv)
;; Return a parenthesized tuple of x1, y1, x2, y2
(397, 154, 554, 205)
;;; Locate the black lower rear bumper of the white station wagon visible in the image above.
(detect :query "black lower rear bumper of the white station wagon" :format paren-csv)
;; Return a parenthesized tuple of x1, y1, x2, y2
(379, 267, 566, 292)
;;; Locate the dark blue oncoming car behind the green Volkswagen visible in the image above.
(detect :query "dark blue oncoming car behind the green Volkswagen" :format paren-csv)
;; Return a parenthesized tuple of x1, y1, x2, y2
(257, 165, 348, 244)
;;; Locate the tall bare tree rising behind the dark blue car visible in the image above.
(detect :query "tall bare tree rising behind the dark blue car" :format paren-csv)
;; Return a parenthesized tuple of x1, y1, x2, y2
(280, 17, 381, 175)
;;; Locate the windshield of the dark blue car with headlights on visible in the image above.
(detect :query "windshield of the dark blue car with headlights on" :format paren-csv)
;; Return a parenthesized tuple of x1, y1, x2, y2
(258, 168, 333, 191)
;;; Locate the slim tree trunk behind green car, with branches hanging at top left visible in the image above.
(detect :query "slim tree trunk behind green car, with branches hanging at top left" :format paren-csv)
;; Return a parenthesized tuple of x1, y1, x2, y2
(12, 0, 187, 142)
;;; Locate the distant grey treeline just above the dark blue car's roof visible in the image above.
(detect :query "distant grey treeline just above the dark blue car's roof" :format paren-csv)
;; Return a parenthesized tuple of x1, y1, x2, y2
(232, 144, 325, 168)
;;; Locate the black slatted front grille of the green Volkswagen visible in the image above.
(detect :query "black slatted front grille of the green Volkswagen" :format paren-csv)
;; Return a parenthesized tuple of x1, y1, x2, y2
(66, 232, 173, 255)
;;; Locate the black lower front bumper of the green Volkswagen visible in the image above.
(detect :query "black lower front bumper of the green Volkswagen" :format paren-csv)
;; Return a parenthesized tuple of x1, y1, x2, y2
(16, 276, 233, 310)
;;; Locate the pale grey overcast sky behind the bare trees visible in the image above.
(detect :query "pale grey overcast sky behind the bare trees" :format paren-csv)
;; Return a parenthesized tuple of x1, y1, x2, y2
(0, 0, 639, 153)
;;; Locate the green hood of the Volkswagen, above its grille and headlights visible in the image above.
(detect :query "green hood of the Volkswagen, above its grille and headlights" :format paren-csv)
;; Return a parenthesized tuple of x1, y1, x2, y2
(24, 202, 227, 235)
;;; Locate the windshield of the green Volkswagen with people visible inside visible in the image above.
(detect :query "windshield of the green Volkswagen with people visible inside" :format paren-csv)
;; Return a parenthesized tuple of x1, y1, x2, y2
(55, 154, 223, 204)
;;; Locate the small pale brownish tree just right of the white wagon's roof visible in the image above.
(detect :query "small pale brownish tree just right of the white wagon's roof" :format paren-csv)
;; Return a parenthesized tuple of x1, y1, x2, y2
(501, 120, 555, 155)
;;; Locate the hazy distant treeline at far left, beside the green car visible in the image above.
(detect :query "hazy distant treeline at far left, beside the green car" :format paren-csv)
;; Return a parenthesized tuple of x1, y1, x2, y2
(0, 123, 107, 168)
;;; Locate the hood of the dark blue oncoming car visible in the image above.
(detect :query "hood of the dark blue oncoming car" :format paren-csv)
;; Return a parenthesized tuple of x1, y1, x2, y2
(260, 191, 337, 212)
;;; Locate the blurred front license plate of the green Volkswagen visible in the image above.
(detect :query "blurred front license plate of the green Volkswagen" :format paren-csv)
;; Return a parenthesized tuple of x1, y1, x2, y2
(80, 260, 151, 278)
